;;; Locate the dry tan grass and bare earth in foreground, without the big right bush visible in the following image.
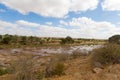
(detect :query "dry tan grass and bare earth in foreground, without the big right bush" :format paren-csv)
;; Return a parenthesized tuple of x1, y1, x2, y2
(0, 44, 120, 80)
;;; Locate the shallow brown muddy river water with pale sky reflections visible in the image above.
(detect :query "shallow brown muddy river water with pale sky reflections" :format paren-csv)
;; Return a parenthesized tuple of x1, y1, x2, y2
(0, 45, 102, 56)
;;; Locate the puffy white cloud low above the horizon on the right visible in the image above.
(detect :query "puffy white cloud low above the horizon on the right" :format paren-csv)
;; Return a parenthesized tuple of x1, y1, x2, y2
(69, 17, 120, 38)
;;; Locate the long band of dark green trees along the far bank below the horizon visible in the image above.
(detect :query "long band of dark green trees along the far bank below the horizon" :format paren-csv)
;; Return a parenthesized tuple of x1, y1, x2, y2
(0, 34, 109, 45)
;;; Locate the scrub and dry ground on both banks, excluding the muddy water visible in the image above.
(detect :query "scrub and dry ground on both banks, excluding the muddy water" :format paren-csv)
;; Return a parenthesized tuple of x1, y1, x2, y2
(0, 35, 120, 80)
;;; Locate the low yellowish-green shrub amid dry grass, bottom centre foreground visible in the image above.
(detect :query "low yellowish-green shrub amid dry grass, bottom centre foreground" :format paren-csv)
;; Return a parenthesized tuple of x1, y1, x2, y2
(45, 53, 67, 77)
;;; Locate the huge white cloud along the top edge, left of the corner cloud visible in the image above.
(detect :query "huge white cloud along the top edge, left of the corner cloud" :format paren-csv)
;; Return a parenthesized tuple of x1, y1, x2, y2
(0, 0, 99, 18)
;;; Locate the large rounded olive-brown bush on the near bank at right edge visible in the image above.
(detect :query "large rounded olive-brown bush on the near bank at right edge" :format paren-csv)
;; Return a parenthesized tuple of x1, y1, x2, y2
(92, 44, 120, 65)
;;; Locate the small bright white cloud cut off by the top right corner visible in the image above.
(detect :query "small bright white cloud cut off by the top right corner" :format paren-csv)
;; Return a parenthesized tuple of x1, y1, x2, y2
(102, 0, 120, 11)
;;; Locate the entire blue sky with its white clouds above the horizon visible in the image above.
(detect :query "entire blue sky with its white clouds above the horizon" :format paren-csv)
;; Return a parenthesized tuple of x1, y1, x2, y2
(0, 0, 120, 39)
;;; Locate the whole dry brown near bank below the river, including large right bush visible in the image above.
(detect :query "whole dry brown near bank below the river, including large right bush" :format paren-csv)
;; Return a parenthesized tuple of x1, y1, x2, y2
(0, 34, 120, 80)
